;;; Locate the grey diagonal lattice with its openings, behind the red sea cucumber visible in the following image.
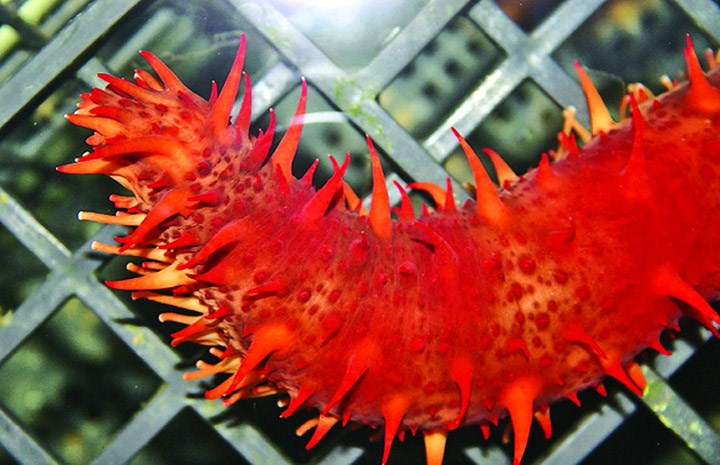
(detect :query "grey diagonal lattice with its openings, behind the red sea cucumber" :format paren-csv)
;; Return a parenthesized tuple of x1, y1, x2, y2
(0, 0, 720, 465)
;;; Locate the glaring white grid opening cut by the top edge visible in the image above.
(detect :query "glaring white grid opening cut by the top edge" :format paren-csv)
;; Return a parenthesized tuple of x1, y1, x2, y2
(270, 0, 427, 71)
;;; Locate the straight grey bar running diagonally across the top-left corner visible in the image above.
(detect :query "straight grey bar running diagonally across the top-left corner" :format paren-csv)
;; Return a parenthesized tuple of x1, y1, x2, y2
(0, 0, 140, 128)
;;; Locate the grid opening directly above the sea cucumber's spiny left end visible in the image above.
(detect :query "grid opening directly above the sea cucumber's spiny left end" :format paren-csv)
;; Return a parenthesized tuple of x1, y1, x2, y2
(89, 0, 278, 98)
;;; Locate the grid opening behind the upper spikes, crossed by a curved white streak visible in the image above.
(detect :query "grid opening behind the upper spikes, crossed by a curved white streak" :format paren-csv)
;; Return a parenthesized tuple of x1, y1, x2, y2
(253, 83, 372, 196)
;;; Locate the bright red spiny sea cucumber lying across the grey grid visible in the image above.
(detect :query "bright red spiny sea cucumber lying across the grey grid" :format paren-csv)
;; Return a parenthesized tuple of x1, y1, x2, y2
(60, 40, 720, 463)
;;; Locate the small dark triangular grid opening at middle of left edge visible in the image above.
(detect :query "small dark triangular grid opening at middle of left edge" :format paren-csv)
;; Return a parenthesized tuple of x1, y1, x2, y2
(0, 222, 48, 316)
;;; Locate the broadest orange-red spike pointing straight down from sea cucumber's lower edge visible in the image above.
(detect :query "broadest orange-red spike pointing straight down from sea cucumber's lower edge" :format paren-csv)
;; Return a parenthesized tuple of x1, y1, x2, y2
(501, 376, 541, 465)
